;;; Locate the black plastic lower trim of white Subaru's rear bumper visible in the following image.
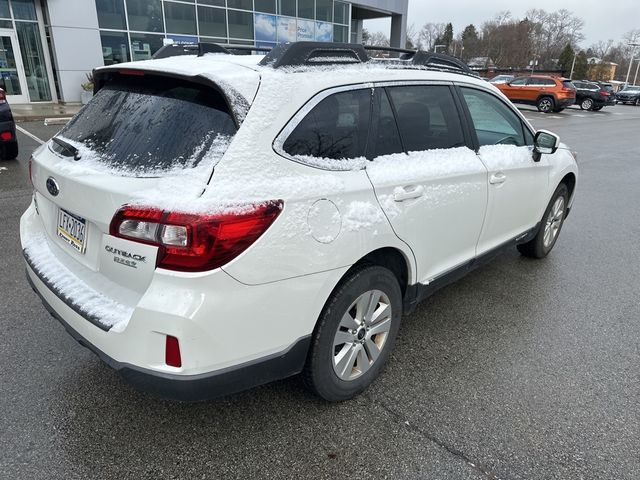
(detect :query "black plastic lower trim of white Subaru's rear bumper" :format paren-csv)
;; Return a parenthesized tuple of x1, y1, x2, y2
(27, 266, 311, 402)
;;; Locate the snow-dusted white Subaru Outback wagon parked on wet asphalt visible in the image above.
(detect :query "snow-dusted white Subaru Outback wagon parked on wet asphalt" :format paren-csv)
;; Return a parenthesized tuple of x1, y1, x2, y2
(20, 42, 578, 400)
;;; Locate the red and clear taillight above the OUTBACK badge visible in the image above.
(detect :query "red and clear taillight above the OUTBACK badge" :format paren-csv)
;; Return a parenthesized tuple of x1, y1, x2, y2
(109, 200, 283, 272)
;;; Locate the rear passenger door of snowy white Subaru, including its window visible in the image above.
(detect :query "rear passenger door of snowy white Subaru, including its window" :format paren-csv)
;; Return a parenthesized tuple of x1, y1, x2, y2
(367, 85, 487, 283)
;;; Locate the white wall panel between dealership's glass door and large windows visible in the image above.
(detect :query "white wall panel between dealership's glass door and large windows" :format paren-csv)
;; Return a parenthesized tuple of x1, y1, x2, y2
(46, 0, 103, 102)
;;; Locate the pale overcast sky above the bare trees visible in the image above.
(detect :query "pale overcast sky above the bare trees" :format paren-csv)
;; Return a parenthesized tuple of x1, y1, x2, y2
(365, 0, 640, 48)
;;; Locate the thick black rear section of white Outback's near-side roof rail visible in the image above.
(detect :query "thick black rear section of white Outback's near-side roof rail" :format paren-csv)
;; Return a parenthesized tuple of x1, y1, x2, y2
(260, 42, 369, 68)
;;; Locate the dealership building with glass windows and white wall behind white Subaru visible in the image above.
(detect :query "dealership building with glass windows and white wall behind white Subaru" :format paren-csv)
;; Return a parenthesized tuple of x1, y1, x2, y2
(0, 0, 408, 104)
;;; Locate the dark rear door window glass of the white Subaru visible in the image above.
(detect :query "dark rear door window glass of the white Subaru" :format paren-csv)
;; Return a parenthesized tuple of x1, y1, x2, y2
(387, 85, 465, 152)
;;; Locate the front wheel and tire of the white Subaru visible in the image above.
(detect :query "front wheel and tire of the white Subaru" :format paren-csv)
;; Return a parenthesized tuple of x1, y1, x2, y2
(517, 183, 569, 258)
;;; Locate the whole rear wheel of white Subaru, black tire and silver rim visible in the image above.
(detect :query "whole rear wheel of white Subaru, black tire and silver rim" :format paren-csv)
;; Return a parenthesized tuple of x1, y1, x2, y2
(303, 265, 402, 402)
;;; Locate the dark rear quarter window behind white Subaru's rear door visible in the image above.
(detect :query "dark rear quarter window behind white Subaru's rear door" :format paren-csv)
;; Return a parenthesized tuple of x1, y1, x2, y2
(283, 89, 371, 160)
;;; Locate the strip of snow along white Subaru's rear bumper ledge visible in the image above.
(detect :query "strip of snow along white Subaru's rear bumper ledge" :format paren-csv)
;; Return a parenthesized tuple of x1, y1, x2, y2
(24, 235, 133, 332)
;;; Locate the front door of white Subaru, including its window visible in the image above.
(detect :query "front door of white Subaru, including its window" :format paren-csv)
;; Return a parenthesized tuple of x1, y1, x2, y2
(460, 86, 549, 255)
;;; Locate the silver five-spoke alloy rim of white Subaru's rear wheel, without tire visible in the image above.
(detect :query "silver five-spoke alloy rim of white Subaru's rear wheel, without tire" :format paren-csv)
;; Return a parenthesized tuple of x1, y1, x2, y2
(333, 290, 393, 381)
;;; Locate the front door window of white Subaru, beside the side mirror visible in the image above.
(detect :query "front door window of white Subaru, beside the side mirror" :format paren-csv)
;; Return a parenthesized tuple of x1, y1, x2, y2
(461, 88, 531, 146)
